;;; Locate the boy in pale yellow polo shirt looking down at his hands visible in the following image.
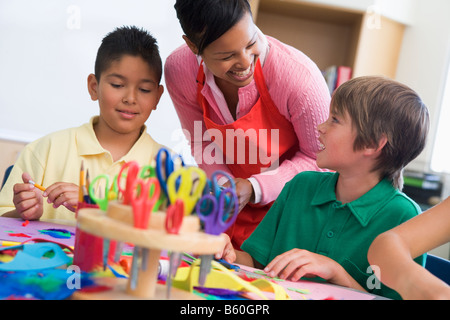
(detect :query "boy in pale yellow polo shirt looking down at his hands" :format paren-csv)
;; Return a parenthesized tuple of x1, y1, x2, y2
(0, 27, 164, 220)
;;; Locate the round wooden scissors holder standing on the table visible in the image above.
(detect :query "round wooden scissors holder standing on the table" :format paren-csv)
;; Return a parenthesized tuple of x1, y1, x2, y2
(75, 201, 226, 299)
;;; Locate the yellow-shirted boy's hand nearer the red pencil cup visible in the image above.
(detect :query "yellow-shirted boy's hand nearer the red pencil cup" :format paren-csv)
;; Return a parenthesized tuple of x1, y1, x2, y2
(43, 182, 79, 212)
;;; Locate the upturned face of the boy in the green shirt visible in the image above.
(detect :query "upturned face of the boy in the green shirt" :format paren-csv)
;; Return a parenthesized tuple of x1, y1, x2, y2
(316, 110, 364, 173)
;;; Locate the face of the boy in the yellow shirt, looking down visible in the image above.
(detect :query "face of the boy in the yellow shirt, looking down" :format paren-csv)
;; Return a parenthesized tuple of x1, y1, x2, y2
(88, 55, 164, 139)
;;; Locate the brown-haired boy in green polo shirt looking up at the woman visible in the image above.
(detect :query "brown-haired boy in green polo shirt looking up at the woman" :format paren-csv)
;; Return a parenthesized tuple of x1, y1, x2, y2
(218, 77, 429, 298)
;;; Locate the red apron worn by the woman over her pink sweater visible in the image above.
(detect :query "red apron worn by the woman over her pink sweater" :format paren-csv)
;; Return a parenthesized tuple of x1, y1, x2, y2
(197, 60, 299, 249)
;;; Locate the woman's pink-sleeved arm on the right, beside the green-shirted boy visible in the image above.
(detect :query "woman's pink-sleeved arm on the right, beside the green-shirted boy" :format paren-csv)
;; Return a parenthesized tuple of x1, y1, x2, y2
(253, 38, 331, 204)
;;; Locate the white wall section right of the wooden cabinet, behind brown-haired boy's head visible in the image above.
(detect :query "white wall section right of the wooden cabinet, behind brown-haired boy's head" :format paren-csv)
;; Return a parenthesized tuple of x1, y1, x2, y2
(396, 0, 450, 171)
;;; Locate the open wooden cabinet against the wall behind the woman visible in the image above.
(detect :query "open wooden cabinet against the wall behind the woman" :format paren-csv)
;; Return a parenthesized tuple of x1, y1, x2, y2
(250, 0, 405, 78)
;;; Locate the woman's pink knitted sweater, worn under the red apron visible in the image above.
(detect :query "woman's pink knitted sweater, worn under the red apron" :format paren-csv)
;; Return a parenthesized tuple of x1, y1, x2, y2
(164, 36, 330, 204)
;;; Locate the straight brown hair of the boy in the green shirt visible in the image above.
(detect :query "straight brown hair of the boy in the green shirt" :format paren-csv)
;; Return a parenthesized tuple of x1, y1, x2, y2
(331, 76, 430, 190)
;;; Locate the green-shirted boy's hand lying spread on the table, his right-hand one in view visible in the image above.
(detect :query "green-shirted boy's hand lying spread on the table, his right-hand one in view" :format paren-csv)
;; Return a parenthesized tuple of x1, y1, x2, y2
(264, 249, 340, 282)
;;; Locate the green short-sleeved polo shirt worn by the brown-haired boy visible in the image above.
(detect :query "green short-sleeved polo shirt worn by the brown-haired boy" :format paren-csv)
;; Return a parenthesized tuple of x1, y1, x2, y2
(242, 172, 424, 299)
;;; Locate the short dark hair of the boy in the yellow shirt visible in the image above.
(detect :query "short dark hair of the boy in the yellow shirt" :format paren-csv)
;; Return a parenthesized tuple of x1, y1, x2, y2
(95, 26, 162, 82)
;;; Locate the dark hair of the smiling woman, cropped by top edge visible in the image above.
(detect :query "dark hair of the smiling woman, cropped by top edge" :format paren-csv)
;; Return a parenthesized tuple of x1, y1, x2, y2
(174, 0, 252, 55)
